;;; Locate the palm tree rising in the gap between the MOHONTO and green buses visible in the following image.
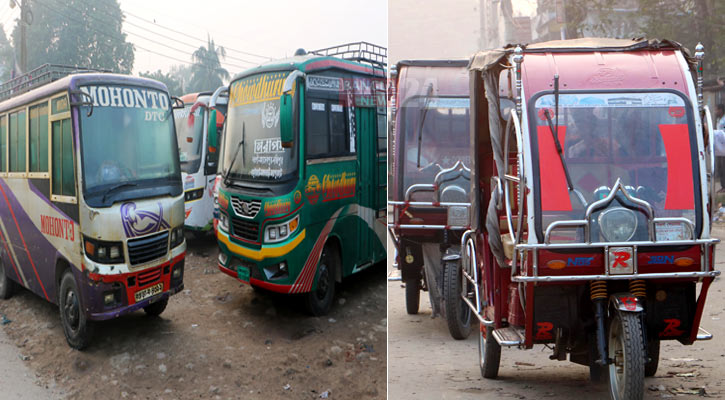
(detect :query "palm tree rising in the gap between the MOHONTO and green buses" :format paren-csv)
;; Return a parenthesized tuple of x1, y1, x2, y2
(189, 37, 229, 92)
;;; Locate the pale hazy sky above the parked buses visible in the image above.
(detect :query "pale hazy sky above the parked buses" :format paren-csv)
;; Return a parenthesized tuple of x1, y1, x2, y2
(0, 0, 388, 76)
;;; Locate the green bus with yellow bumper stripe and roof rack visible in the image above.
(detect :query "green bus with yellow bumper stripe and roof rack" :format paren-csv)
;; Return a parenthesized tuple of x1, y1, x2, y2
(217, 42, 387, 315)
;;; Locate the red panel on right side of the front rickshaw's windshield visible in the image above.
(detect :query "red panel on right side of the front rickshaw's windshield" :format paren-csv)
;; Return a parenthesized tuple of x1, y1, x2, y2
(659, 124, 695, 210)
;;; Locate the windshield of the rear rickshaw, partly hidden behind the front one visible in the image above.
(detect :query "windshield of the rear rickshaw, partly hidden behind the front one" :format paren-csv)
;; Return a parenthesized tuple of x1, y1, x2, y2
(401, 97, 470, 201)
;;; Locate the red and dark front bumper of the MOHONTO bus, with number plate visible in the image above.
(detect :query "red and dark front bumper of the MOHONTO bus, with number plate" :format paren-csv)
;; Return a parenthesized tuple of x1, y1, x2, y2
(79, 251, 186, 321)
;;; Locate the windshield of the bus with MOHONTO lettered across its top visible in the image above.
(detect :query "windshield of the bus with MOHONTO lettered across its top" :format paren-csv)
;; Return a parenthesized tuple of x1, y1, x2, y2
(80, 85, 180, 206)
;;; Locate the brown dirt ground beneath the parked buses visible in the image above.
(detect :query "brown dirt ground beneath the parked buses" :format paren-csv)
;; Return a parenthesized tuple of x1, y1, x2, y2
(0, 237, 387, 399)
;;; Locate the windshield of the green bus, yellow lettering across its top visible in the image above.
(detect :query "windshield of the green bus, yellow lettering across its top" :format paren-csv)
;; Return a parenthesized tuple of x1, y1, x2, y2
(221, 71, 297, 181)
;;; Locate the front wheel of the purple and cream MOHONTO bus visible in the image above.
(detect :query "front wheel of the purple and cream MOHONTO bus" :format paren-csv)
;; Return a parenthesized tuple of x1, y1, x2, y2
(58, 270, 93, 350)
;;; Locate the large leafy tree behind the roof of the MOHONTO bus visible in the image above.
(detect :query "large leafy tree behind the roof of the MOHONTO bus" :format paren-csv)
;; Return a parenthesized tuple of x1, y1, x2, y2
(12, 0, 134, 73)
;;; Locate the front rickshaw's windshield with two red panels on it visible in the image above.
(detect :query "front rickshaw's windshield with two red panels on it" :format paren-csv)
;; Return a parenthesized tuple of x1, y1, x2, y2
(533, 92, 697, 241)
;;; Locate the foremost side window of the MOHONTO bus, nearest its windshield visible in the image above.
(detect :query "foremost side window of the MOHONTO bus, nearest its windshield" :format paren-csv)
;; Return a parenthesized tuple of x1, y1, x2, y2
(51, 118, 76, 197)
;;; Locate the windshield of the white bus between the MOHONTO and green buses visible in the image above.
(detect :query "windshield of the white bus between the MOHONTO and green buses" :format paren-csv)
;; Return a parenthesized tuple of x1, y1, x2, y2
(174, 104, 204, 174)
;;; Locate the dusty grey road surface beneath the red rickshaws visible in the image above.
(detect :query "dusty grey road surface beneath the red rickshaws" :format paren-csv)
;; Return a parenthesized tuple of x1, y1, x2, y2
(388, 226, 725, 400)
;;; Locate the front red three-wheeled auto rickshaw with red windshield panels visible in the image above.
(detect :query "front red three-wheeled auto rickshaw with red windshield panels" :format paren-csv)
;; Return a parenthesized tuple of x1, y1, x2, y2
(461, 38, 720, 399)
